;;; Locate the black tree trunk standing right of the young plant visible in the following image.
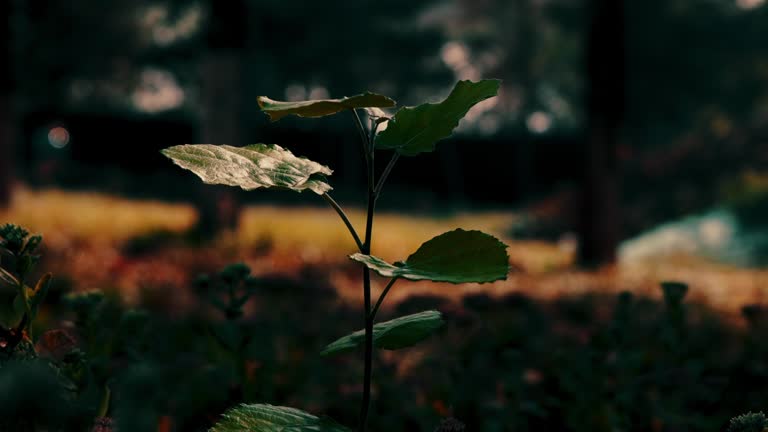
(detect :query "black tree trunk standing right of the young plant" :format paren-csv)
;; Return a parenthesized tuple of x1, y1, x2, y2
(578, 0, 625, 266)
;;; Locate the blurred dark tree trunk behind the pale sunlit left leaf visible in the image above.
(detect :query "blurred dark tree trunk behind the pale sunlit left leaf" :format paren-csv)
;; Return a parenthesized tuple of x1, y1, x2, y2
(196, 0, 247, 237)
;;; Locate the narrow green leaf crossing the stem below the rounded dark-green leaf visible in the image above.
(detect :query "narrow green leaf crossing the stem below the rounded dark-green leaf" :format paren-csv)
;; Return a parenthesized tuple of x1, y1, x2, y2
(320, 310, 443, 356)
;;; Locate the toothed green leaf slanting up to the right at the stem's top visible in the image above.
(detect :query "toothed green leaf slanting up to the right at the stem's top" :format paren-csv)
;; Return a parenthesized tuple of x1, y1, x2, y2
(376, 80, 501, 156)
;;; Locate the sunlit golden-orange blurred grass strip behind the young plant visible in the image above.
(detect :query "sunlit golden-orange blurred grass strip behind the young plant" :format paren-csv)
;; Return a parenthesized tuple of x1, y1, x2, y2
(0, 189, 768, 314)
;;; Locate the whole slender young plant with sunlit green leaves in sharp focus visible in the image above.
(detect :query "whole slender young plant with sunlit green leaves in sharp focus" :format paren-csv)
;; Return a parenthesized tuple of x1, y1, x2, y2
(162, 80, 509, 432)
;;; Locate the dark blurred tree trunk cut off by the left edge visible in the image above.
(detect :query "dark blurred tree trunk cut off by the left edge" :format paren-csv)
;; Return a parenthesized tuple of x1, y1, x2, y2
(0, 1, 15, 208)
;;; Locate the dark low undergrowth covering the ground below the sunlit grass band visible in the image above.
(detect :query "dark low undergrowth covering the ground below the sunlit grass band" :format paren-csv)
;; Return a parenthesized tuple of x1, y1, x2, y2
(0, 223, 768, 432)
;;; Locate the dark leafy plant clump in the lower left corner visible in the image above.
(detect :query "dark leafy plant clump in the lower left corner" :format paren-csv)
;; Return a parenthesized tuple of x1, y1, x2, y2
(0, 224, 110, 432)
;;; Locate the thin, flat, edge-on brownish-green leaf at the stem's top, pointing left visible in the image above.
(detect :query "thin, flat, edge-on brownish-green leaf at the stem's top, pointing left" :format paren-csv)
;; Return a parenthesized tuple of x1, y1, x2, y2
(258, 92, 395, 121)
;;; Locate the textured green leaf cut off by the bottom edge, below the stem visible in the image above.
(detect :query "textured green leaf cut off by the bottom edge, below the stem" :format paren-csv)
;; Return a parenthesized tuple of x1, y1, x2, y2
(210, 404, 350, 432)
